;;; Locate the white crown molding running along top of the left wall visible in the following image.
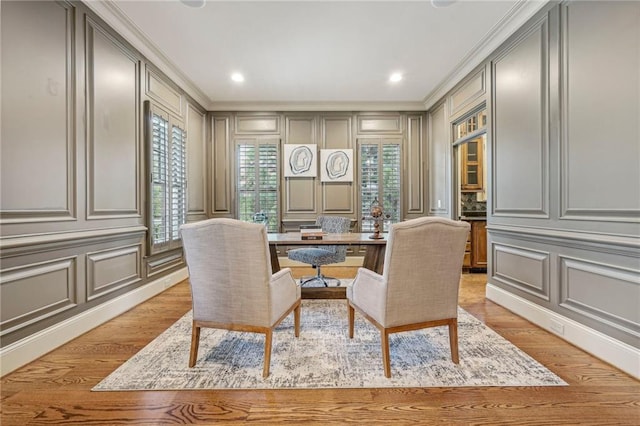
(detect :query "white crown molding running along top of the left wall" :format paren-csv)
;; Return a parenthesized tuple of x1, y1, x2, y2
(83, 0, 211, 109)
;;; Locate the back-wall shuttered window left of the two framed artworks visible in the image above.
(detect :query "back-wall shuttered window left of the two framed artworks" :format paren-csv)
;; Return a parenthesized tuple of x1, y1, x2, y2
(236, 139, 280, 232)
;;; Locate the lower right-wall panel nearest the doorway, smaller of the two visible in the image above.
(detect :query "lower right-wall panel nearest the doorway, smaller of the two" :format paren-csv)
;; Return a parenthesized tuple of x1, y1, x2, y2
(490, 242, 550, 301)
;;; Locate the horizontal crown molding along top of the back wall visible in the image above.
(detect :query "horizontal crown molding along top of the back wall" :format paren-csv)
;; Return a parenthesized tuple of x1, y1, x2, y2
(209, 102, 425, 111)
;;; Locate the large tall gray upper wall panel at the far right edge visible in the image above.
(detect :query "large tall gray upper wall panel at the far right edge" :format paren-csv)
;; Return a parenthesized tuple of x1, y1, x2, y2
(560, 2, 640, 223)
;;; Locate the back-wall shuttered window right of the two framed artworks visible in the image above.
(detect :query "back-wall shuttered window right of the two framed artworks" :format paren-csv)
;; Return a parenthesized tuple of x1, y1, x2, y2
(360, 139, 402, 232)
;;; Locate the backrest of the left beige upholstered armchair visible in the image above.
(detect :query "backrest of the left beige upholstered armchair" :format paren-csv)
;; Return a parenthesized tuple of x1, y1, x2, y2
(180, 219, 272, 326)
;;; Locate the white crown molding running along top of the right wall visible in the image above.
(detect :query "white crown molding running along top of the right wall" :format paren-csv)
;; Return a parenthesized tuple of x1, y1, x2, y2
(424, 0, 550, 110)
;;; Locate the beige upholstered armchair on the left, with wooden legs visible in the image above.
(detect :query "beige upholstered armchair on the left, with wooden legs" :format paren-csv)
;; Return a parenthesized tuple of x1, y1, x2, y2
(180, 219, 300, 377)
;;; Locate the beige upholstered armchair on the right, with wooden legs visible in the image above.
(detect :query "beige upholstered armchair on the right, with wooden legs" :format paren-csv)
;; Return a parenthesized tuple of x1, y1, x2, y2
(347, 217, 470, 377)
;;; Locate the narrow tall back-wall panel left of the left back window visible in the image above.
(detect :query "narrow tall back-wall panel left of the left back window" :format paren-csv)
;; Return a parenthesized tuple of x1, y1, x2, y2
(210, 116, 234, 214)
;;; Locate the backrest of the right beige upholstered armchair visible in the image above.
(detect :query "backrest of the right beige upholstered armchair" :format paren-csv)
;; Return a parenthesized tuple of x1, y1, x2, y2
(383, 217, 470, 324)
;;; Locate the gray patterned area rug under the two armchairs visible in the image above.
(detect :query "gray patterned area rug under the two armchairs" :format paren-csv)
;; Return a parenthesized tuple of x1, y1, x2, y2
(93, 299, 566, 391)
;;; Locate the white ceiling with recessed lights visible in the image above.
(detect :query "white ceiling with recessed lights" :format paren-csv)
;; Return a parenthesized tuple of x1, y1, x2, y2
(100, 0, 543, 110)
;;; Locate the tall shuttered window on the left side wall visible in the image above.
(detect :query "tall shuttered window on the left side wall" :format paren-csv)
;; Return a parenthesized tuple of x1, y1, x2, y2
(149, 104, 187, 253)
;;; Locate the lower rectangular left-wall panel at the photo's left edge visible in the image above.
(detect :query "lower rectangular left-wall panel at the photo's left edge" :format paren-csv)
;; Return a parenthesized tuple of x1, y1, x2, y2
(0, 256, 77, 336)
